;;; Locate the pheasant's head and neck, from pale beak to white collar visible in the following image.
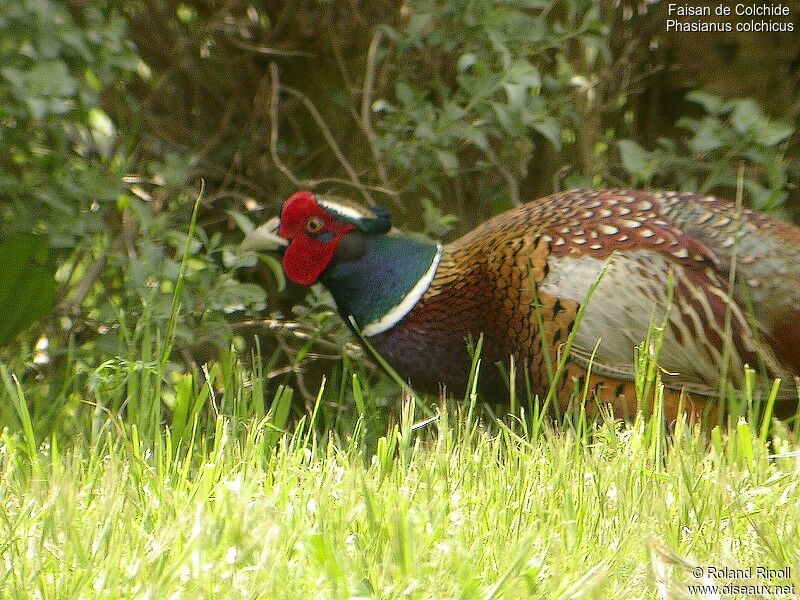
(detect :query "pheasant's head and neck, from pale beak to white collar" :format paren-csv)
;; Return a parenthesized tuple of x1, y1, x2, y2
(242, 191, 441, 336)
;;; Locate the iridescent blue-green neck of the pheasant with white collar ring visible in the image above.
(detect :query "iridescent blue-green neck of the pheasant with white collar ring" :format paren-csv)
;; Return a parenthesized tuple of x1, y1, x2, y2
(322, 232, 442, 336)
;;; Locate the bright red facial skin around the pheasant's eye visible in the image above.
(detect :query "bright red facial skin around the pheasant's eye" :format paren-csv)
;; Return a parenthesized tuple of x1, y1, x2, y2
(278, 192, 355, 285)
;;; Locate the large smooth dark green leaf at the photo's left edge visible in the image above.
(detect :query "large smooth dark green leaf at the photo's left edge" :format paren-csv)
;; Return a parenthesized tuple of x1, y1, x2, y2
(0, 234, 56, 345)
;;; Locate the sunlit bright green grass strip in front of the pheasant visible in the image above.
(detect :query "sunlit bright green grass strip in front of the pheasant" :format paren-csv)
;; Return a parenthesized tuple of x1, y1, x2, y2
(0, 365, 800, 599)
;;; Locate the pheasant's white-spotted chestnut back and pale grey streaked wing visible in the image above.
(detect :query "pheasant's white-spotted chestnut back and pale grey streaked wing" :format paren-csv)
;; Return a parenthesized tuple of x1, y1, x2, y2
(451, 190, 800, 396)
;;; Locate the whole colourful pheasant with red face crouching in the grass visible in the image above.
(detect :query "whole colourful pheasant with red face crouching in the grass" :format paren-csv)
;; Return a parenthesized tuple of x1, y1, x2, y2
(242, 190, 800, 420)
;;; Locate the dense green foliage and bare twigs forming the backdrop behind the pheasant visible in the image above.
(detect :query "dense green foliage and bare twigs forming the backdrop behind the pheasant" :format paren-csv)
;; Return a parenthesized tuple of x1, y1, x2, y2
(0, 0, 800, 431)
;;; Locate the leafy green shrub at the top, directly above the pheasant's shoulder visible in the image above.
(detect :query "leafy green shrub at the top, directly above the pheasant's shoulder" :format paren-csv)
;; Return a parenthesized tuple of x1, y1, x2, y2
(373, 0, 611, 212)
